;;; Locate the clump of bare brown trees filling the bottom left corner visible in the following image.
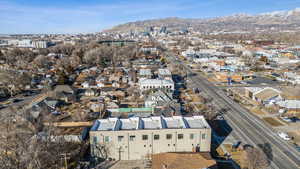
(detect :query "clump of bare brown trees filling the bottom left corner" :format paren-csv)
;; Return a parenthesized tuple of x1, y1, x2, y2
(0, 108, 84, 169)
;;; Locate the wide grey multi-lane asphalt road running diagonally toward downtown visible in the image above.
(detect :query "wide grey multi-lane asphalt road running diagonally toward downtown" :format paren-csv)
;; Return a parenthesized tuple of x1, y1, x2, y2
(169, 57, 300, 169)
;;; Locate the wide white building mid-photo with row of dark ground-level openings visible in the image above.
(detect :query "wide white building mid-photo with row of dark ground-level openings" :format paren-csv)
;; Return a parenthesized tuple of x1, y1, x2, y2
(139, 78, 174, 91)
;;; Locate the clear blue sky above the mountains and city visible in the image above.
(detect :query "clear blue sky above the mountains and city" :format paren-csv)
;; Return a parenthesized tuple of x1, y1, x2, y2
(0, 0, 300, 34)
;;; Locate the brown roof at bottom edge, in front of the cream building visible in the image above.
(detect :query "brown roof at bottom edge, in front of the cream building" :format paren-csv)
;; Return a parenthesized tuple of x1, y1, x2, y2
(152, 152, 216, 169)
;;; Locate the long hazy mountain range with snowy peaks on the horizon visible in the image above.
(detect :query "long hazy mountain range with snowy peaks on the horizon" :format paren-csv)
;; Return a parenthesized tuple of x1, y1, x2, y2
(106, 8, 300, 33)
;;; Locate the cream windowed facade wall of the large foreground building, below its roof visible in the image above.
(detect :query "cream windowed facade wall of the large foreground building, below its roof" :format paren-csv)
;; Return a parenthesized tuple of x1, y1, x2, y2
(90, 129, 211, 160)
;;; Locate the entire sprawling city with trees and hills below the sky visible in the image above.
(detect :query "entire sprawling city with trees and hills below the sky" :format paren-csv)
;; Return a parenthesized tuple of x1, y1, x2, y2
(0, 3, 300, 169)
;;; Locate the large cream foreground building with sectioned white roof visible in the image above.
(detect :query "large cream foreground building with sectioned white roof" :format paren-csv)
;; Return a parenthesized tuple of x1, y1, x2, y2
(90, 116, 211, 160)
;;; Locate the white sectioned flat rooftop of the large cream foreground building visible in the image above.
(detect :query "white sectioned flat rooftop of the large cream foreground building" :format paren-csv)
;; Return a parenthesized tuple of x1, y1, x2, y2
(91, 116, 210, 131)
